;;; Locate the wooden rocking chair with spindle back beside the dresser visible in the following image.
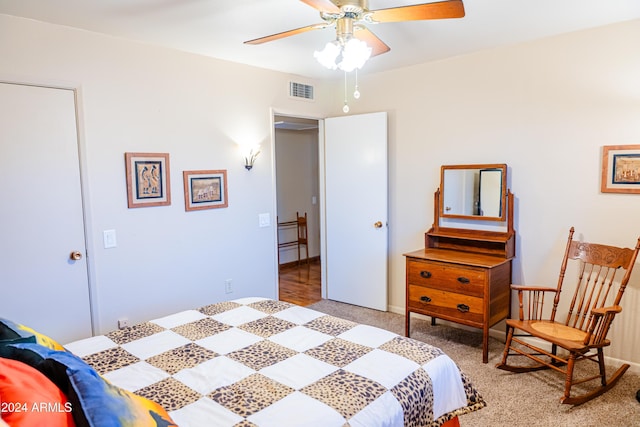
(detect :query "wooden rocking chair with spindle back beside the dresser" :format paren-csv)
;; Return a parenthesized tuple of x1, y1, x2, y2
(496, 227, 640, 405)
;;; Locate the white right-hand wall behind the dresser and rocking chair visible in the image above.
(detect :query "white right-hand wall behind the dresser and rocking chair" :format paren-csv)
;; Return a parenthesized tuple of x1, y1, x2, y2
(334, 21, 640, 363)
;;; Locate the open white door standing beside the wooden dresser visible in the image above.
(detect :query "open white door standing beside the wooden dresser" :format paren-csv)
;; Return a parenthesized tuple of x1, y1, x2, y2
(324, 112, 388, 311)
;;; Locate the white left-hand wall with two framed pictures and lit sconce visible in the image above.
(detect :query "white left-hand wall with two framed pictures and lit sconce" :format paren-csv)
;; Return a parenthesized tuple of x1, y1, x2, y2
(0, 15, 330, 333)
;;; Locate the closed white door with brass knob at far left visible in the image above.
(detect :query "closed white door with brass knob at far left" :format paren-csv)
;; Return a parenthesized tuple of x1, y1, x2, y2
(0, 83, 91, 343)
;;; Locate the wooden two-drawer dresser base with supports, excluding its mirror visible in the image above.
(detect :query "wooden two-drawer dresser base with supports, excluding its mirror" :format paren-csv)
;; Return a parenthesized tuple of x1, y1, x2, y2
(404, 192, 515, 363)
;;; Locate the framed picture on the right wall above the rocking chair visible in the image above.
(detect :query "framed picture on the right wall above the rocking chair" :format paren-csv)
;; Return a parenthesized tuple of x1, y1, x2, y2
(601, 145, 640, 194)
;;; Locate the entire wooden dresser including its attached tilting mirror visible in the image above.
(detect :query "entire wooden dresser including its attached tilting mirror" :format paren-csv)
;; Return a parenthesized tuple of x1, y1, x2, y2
(410, 164, 516, 363)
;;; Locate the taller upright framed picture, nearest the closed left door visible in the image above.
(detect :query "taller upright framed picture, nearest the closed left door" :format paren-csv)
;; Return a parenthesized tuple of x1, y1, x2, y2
(124, 153, 171, 208)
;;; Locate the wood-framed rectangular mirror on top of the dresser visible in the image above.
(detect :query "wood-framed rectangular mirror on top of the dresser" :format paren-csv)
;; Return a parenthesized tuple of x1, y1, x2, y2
(439, 164, 507, 221)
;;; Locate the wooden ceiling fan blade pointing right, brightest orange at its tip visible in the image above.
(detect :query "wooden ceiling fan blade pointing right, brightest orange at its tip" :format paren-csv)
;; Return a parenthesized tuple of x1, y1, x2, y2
(369, 0, 464, 22)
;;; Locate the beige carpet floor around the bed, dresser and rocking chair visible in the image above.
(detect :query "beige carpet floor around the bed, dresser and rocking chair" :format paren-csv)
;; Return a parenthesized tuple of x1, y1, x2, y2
(309, 300, 640, 427)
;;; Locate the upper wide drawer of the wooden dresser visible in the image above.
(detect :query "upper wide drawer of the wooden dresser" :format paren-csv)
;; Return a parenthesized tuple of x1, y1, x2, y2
(407, 259, 487, 297)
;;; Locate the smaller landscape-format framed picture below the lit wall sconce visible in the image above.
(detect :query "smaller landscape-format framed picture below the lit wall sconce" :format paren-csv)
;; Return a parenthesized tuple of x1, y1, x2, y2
(182, 170, 229, 211)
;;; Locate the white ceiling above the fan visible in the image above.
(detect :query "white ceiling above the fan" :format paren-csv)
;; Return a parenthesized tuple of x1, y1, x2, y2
(0, 0, 640, 78)
